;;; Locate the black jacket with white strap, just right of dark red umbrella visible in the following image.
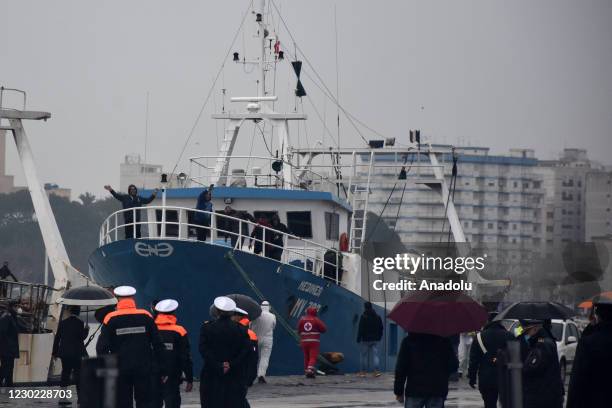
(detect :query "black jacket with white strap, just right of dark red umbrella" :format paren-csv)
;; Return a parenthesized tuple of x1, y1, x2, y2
(468, 322, 514, 389)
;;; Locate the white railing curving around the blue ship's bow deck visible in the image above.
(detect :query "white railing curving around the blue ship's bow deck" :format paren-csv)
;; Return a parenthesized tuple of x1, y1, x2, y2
(99, 206, 342, 285)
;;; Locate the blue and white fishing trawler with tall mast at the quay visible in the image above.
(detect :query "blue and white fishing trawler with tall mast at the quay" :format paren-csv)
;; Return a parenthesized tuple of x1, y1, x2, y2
(89, 1, 478, 375)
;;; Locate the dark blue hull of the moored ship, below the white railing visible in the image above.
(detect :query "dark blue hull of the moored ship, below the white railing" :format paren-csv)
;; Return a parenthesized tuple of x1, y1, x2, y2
(89, 239, 398, 375)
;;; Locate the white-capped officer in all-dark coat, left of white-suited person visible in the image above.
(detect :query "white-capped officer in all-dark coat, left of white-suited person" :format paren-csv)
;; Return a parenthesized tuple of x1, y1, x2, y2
(199, 296, 250, 408)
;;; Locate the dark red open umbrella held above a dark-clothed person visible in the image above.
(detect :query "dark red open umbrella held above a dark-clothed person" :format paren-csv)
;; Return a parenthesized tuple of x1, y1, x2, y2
(389, 291, 488, 337)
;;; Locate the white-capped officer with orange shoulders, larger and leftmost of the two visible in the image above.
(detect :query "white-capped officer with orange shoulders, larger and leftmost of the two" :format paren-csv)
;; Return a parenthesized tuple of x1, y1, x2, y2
(96, 286, 167, 408)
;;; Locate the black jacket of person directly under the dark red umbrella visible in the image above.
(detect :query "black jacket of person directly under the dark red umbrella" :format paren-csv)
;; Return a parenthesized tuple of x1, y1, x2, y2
(393, 333, 459, 397)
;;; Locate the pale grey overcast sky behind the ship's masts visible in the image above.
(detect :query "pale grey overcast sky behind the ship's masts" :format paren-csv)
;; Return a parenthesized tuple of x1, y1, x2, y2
(0, 0, 612, 198)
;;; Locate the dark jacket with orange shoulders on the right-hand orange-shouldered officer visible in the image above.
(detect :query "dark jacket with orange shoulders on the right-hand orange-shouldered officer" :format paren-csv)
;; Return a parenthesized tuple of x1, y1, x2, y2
(155, 313, 193, 383)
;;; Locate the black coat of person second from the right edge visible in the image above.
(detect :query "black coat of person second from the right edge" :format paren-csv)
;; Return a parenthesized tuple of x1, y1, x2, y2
(519, 329, 564, 408)
